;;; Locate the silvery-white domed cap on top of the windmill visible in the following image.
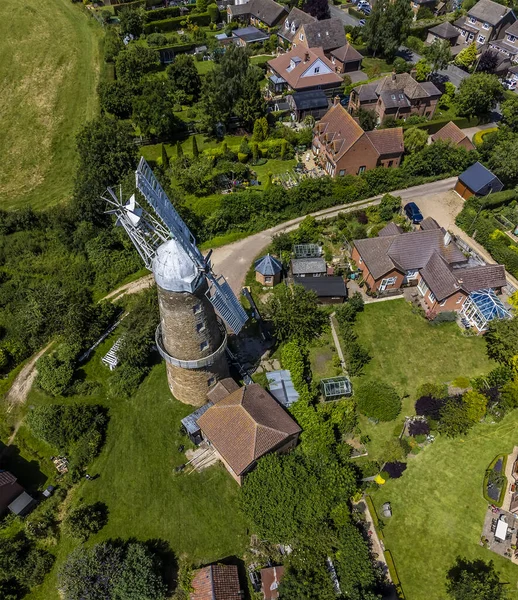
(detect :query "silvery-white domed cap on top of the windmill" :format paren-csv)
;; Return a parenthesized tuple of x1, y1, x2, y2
(153, 239, 201, 292)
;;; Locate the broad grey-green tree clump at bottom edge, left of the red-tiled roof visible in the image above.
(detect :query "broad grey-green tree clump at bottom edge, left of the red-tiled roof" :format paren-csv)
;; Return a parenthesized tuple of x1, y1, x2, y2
(58, 540, 166, 600)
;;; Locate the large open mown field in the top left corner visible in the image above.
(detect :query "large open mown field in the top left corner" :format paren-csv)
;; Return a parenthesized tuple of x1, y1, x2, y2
(0, 0, 102, 208)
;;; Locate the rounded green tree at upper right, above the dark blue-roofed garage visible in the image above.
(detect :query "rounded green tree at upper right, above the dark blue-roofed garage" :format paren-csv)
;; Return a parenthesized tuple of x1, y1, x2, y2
(455, 73, 504, 117)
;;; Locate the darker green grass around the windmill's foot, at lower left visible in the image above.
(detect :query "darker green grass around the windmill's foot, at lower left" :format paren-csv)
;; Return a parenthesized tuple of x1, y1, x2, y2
(13, 337, 247, 600)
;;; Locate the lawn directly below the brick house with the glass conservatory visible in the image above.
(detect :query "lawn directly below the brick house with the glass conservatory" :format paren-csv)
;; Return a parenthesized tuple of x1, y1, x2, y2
(353, 299, 495, 459)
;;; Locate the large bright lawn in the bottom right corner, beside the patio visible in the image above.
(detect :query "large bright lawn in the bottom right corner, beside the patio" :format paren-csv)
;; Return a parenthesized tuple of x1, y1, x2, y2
(373, 412, 518, 600)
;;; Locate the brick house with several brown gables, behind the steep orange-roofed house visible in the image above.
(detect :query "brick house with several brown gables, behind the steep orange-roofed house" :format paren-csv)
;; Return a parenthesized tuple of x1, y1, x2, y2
(349, 73, 441, 123)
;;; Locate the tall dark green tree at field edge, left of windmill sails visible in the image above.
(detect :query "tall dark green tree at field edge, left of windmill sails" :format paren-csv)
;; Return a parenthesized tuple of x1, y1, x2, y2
(73, 116, 137, 223)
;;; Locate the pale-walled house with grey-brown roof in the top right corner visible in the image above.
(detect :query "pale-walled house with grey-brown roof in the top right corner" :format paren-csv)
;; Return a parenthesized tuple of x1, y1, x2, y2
(453, 0, 516, 46)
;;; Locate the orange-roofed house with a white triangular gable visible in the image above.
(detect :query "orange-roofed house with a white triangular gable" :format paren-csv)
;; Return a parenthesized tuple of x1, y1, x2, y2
(268, 48, 342, 95)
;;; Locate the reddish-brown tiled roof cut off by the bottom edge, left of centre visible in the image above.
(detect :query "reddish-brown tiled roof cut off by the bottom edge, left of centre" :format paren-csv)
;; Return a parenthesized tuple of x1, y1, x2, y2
(190, 565, 243, 600)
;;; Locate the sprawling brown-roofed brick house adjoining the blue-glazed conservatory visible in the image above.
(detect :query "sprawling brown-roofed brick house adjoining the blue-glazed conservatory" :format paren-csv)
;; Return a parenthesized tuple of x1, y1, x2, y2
(352, 219, 506, 312)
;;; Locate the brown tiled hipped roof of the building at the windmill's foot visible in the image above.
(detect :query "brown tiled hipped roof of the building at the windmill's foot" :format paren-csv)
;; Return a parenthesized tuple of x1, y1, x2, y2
(198, 383, 301, 475)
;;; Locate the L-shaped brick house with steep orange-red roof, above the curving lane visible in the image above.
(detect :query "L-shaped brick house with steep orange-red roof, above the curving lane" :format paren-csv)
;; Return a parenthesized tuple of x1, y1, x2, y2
(313, 100, 405, 177)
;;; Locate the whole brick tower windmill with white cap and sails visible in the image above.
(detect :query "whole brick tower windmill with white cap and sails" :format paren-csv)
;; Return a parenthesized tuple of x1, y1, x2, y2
(103, 158, 248, 406)
